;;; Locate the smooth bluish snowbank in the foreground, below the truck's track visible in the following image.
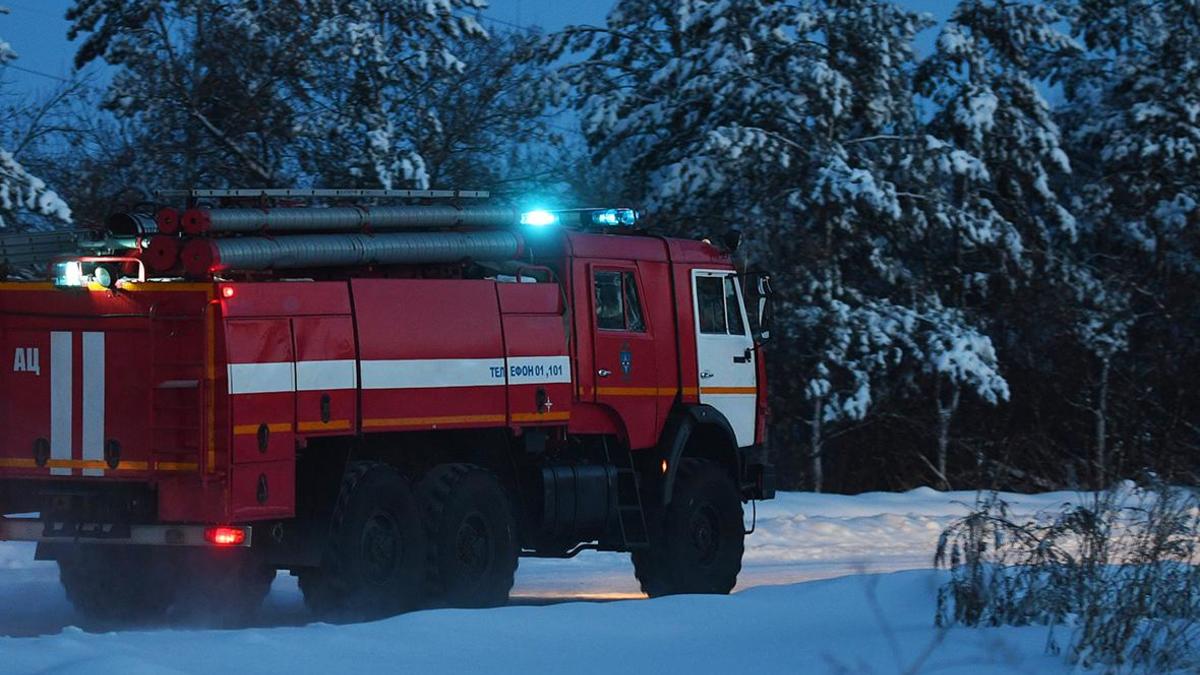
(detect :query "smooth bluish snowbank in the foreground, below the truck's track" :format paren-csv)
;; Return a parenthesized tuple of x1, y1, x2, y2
(0, 572, 1067, 675)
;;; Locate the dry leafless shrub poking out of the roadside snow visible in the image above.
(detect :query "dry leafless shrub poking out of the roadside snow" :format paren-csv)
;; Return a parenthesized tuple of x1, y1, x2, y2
(935, 477, 1200, 673)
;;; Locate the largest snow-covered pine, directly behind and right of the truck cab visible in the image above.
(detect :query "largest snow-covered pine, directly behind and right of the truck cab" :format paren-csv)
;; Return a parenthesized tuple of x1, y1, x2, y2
(548, 0, 1008, 489)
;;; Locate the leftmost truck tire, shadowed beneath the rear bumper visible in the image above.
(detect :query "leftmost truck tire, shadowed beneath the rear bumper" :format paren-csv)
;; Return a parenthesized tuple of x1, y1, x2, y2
(59, 544, 175, 623)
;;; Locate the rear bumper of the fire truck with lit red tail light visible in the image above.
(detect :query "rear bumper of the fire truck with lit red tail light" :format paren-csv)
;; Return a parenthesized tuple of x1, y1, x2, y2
(0, 518, 253, 548)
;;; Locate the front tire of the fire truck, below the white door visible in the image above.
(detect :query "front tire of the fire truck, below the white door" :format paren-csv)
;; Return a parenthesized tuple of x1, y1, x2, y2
(632, 459, 745, 598)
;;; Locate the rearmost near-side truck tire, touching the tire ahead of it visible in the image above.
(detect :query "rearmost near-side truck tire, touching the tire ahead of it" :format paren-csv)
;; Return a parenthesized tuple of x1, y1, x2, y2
(299, 462, 426, 621)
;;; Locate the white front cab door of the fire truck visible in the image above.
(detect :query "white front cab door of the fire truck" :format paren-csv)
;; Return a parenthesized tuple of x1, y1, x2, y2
(691, 270, 757, 447)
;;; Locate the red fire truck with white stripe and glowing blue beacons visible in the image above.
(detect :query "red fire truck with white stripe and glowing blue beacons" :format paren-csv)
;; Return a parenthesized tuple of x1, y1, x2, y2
(0, 190, 774, 620)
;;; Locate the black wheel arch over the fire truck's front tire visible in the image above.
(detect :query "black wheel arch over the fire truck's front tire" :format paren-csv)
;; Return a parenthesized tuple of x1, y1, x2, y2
(661, 404, 742, 506)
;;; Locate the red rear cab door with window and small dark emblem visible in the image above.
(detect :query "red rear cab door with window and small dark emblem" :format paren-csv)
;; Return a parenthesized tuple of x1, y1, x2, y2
(588, 263, 660, 448)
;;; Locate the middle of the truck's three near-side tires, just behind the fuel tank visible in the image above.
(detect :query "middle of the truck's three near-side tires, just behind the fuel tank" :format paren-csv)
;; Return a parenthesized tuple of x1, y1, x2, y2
(416, 464, 521, 608)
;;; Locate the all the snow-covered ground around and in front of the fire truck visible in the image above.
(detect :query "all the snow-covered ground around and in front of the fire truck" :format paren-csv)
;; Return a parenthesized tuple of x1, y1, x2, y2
(0, 489, 1078, 675)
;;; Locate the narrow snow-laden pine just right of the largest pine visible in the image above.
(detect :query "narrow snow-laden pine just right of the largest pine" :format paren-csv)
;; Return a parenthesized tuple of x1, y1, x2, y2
(917, 0, 1079, 480)
